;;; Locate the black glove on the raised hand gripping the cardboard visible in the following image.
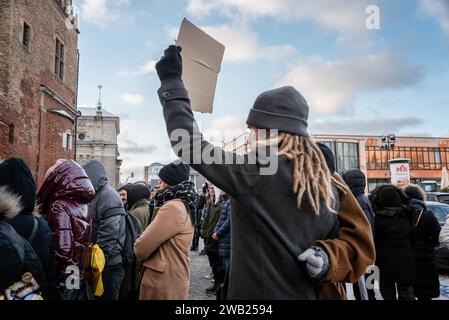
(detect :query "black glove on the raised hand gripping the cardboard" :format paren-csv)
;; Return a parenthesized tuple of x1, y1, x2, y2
(156, 45, 182, 83)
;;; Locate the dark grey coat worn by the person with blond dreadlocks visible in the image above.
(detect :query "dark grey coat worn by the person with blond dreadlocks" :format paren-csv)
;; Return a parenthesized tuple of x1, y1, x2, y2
(159, 80, 338, 300)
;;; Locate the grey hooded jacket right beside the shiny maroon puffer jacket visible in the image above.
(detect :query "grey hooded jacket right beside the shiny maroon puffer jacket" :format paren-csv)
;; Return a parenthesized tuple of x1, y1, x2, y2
(83, 160, 126, 266)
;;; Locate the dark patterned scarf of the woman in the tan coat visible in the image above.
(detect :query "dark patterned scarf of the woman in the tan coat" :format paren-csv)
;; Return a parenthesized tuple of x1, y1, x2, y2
(155, 181, 197, 224)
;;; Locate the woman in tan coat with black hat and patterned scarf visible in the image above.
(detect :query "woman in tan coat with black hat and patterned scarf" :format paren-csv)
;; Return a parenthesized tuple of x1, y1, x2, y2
(134, 162, 196, 300)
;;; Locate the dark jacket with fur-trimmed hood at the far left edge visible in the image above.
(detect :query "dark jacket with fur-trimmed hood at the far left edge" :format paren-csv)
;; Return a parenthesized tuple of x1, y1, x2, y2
(0, 187, 47, 296)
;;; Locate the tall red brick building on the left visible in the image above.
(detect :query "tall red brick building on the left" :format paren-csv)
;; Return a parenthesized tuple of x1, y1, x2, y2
(0, 0, 79, 185)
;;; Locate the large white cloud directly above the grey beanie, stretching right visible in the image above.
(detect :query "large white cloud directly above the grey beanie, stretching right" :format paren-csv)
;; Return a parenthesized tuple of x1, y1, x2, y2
(278, 53, 424, 114)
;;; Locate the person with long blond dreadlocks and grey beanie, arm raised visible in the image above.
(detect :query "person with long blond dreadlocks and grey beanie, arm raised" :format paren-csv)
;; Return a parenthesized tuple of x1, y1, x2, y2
(156, 46, 374, 299)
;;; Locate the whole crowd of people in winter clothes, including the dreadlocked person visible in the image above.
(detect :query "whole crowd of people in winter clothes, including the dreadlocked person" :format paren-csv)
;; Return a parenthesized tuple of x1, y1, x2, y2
(0, 46, 449, 300)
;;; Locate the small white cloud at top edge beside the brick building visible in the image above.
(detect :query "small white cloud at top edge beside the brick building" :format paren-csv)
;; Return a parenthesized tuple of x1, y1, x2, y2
(81, 0, 130, 28)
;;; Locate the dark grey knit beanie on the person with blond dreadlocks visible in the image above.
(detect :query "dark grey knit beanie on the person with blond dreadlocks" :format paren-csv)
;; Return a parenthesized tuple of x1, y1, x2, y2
(246, 86, 309, 137)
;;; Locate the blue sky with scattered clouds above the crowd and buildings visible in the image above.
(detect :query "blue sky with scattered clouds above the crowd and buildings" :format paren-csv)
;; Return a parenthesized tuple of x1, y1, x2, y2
(74, 0, 449, 180)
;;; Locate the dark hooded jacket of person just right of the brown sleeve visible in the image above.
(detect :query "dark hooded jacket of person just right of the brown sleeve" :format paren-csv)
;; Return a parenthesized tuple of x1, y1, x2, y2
(342, 170, 376, 234)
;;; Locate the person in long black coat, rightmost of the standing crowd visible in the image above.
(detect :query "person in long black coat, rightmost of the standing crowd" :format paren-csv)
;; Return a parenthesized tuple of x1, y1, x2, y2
(404, 184, 441, 300)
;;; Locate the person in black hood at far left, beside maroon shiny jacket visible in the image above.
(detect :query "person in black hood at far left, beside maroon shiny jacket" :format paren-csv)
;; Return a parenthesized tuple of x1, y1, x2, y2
(0, 158, 52, 277)
